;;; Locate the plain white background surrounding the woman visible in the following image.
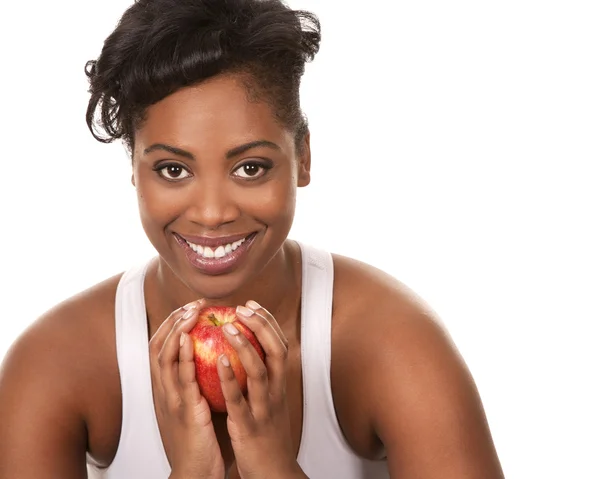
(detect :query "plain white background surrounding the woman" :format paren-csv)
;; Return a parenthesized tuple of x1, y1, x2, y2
(0, 0, 600, 479)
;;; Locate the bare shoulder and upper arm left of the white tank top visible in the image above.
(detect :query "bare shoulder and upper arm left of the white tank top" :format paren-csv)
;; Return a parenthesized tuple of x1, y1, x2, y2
(0, 275, 120, 478)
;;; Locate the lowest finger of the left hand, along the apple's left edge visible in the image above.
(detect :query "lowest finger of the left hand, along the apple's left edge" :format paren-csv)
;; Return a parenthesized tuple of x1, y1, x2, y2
(178, 333, 211, 426)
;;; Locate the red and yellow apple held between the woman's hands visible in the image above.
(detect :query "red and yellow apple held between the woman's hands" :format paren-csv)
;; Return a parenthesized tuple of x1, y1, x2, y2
(189, 306, 265, 412)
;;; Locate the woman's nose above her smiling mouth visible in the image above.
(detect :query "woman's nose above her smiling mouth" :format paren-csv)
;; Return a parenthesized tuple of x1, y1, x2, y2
(186, 178, 240, 229)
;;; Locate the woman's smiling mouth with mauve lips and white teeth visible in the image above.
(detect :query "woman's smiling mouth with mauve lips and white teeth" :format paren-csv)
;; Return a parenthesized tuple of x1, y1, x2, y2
(174, 232, 257, 275)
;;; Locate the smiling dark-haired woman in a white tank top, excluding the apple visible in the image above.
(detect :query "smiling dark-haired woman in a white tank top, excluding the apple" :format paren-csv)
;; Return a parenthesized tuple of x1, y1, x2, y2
(0, 0, 502, 479)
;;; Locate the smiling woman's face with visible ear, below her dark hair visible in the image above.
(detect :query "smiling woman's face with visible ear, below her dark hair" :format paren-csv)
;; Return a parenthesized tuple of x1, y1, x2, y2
(133, 75, 310, 298)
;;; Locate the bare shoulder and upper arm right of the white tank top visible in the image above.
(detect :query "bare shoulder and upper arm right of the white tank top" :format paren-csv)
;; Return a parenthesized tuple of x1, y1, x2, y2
(331, 256, 502, 479)
